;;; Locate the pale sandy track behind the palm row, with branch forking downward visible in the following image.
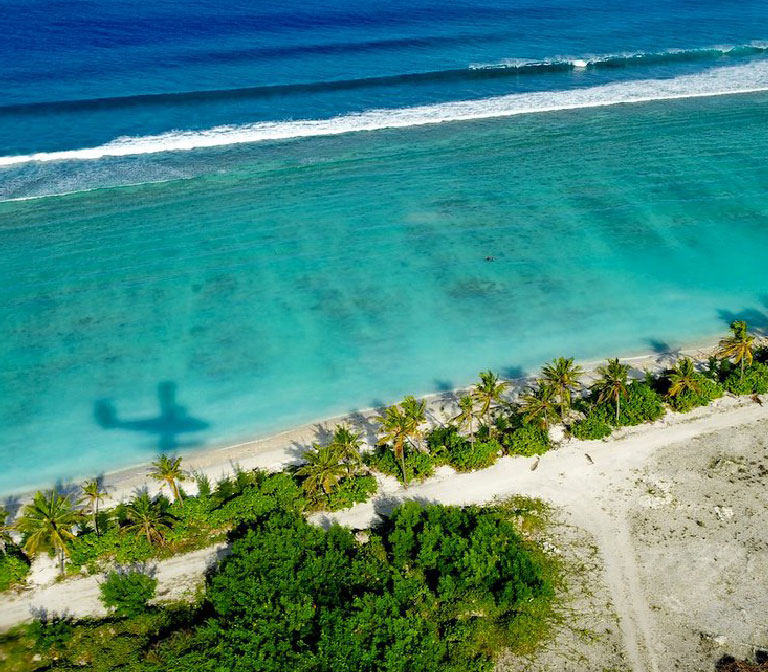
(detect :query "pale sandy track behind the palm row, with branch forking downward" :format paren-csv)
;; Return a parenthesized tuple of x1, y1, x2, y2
(0, 398, 768, 672)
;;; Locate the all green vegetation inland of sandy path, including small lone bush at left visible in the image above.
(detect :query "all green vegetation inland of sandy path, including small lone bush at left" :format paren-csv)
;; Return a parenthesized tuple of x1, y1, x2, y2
(0, 496, 558, 672)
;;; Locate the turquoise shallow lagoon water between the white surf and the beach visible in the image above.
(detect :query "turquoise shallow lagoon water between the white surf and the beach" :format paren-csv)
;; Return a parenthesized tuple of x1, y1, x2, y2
(0, 94, 768, 492)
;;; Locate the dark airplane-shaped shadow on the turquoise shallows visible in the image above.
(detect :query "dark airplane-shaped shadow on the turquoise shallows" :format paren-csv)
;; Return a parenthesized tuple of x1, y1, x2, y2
(93, 381, 210, 452)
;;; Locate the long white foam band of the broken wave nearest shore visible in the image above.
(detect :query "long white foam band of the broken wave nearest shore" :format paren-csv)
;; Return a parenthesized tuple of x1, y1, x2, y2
(0, 61, 768, 166)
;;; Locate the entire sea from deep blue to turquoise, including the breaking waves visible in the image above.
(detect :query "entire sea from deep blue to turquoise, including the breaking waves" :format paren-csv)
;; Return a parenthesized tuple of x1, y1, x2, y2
(0, 0, 768, 492)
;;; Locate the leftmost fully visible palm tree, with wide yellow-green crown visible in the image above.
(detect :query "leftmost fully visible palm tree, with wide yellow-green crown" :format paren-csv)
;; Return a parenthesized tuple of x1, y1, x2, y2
(16, 490, 80, 574)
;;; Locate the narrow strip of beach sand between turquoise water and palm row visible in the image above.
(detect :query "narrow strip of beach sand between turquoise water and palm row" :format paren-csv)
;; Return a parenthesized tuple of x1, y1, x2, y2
(0, 340, 716, 509)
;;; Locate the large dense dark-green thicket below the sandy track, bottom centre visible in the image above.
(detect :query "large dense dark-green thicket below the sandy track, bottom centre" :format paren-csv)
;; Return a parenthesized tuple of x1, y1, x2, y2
(162, 503, 554, 672)
